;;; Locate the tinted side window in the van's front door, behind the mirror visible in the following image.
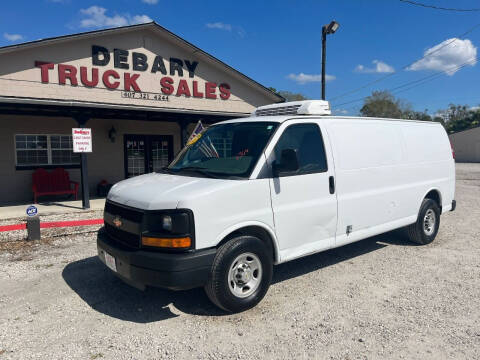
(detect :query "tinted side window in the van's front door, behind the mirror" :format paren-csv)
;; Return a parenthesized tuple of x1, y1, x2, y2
(274, 124, 328, 175)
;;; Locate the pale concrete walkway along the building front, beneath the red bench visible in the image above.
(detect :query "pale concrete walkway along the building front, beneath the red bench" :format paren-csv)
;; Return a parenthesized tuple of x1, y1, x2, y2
(0, 199, 105, 220)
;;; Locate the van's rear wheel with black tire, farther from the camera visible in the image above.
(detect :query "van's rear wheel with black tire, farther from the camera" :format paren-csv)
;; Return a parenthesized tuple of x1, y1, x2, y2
(407, 199, 440, 245)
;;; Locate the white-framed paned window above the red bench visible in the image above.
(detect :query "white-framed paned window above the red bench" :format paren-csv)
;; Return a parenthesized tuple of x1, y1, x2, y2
(15, 134, 80, 167)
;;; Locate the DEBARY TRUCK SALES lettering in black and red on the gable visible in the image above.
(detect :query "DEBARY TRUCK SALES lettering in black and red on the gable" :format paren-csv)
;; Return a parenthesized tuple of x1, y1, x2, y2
(35, 45, 231, 101)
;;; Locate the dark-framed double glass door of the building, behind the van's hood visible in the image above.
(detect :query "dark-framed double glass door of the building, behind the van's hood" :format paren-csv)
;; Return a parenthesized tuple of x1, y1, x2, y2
(124, 135, 173, 178)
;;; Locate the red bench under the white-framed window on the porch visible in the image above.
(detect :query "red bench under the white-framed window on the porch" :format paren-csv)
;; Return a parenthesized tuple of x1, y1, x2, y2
(32, 168, 78, 204)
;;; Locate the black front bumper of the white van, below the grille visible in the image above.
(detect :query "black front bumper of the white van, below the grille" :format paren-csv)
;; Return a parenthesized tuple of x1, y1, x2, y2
(97, 230, 216, 290)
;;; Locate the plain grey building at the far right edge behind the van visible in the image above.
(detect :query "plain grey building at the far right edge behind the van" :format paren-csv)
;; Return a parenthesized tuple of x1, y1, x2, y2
(449, 127, 480, 162)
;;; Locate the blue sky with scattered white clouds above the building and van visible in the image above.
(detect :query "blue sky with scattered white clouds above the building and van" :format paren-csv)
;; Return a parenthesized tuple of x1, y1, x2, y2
(0, 0, 480, 115)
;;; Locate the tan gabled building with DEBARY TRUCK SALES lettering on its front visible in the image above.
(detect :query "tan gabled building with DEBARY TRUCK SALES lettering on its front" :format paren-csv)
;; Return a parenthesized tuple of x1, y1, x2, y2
(0, 23, 283, 205)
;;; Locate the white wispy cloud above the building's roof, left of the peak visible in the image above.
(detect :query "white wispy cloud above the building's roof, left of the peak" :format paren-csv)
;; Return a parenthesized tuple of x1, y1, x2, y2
(80, 5, 152, 28)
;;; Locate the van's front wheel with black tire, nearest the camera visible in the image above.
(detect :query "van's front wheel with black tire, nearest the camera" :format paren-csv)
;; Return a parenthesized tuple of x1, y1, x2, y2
(205, 236, 273, 313)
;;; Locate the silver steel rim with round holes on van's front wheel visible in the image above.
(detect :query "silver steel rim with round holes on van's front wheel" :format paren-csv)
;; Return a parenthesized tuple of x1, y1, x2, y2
(228, 253, 262, 298)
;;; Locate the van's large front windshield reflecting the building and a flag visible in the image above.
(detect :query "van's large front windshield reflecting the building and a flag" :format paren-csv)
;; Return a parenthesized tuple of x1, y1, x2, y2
(165, 122, 278, 178)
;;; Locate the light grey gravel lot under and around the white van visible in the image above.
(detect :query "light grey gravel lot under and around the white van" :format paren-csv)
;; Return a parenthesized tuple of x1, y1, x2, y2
(0, 164, 480, 359)
